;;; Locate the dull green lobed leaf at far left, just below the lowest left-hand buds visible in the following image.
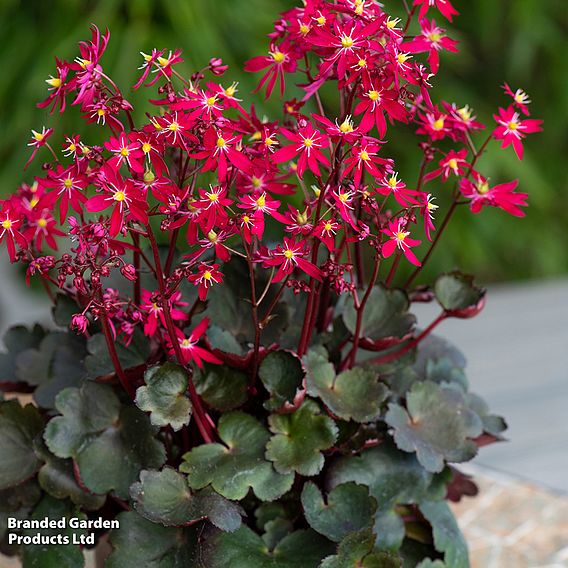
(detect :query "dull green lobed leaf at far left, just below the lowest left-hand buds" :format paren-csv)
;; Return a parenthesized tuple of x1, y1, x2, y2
(16, 331, 87, 409)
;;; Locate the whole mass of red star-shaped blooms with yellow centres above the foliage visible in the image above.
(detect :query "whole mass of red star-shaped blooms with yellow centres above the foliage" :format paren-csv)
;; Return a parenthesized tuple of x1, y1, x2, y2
(0, 0, 541, 365)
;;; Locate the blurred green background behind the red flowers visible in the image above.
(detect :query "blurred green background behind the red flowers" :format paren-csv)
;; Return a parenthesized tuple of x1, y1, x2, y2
(0, 0, 568, 282)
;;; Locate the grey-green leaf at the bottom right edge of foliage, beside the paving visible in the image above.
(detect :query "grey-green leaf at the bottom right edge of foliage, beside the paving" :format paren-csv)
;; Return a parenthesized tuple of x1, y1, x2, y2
(420, 501, 469, 568)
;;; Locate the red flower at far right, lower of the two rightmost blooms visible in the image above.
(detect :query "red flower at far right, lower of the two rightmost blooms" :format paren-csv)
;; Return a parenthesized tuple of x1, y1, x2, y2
(460, 172, 528, 217)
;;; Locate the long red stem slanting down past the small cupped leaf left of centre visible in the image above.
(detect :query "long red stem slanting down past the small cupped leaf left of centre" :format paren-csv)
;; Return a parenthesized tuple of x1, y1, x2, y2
(146, 224, 214, 444)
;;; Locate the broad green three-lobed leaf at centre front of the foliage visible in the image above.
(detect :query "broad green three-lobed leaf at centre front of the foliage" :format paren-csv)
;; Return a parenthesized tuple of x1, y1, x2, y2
(180, 412, 294, 501)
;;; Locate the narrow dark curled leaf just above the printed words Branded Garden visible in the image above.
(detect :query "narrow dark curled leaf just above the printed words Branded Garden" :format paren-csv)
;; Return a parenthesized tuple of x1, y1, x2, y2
(35, 440, 106, 511)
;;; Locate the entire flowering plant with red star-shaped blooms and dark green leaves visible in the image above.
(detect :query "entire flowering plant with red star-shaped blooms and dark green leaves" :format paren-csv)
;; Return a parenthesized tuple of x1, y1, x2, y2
(0, 0, 541, 568)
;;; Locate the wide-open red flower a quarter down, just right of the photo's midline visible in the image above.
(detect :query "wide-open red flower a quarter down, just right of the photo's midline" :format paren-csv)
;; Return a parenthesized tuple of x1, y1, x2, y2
(272, 123, 329, 177)
